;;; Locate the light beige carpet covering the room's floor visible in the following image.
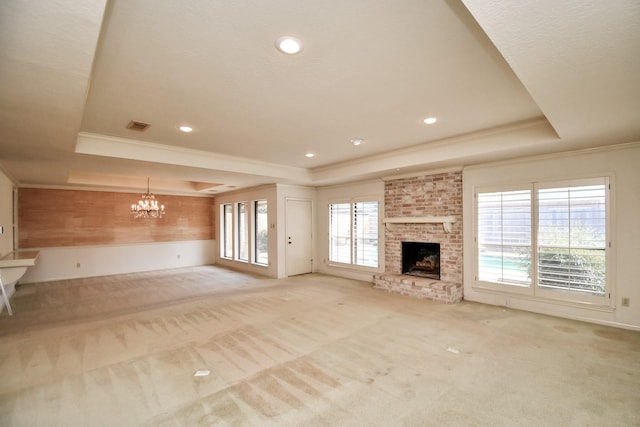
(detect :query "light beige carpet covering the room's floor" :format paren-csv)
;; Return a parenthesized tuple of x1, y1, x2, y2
(0, 267, 640, 427)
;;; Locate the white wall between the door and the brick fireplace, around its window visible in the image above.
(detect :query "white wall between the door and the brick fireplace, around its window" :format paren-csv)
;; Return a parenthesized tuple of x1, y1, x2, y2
(316, 180, 385, 282)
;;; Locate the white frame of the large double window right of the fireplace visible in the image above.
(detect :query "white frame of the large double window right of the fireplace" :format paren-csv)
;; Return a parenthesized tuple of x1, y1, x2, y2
(473, 176, 615, 308)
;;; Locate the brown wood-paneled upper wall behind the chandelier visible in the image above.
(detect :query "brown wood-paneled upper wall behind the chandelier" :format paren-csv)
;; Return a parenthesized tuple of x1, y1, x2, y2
(18, 188, 215, 249)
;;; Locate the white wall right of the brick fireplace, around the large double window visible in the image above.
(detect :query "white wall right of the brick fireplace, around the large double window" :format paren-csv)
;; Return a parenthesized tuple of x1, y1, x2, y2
(463, 143, 640, 330)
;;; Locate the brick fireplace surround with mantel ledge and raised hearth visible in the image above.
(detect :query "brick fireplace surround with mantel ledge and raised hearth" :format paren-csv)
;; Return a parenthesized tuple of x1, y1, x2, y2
(373, 171, 463, 304)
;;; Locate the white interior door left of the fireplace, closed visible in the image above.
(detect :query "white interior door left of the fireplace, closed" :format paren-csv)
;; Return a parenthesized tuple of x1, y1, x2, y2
(285, 199, 313, 276)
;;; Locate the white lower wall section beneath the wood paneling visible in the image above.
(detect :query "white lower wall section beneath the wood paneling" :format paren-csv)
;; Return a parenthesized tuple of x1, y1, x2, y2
(20, 240, 216, 283)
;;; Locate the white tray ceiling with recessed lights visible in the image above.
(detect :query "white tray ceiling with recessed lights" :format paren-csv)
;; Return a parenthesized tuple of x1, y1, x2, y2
(0, 0, 640, 194)
